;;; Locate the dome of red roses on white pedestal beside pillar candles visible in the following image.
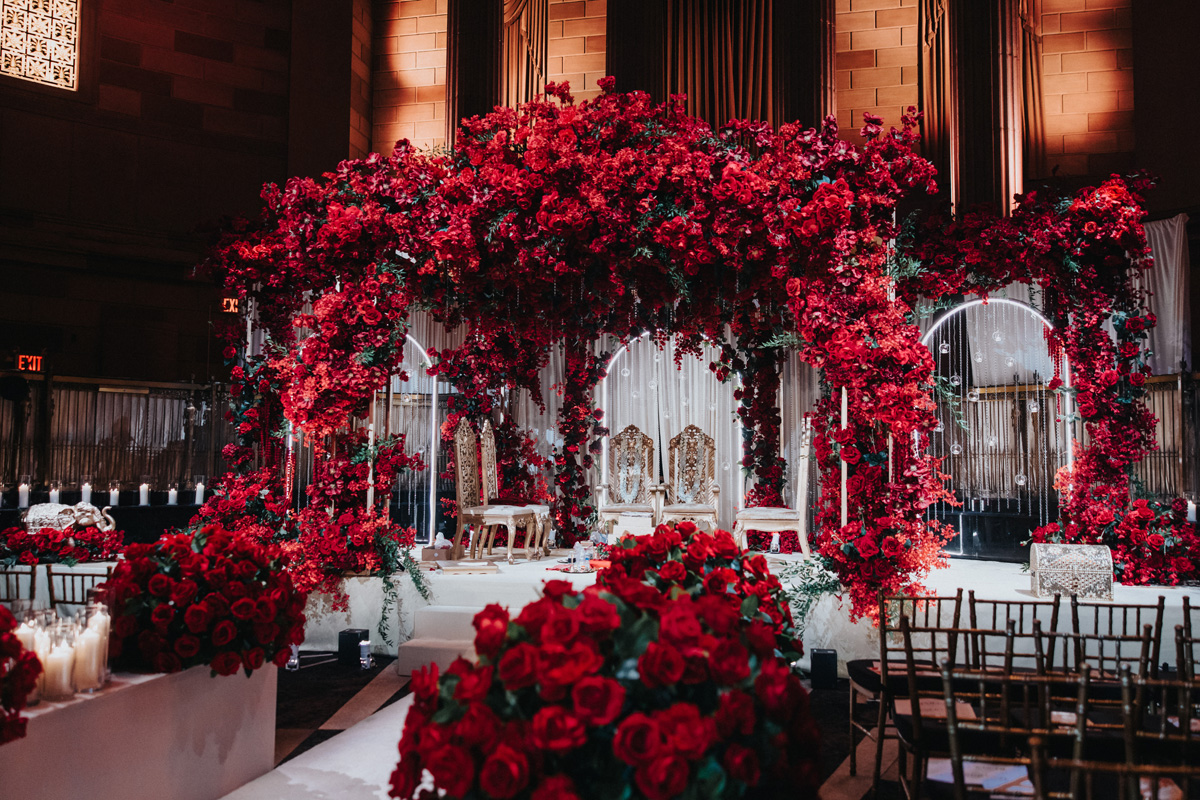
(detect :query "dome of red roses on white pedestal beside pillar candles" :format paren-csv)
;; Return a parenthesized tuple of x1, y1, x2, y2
(106, 525, 307, 675)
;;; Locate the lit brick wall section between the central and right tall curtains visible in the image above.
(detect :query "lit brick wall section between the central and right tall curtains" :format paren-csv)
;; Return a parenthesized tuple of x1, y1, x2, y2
(835, 0, 919, 142)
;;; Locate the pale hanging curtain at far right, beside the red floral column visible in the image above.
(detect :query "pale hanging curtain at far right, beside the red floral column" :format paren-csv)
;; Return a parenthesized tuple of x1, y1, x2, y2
(1142, 213, 1193, 375)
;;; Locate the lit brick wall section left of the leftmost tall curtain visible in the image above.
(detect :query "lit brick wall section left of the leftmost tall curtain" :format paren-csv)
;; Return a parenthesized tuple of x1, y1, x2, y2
(371, 0, 446, 154)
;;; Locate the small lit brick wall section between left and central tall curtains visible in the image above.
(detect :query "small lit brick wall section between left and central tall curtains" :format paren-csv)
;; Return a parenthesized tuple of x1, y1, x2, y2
(546, 0, 609, 102)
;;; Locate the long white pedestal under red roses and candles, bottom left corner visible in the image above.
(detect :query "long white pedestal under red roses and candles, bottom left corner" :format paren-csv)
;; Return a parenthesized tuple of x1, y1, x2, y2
(0, 666, 278, 800)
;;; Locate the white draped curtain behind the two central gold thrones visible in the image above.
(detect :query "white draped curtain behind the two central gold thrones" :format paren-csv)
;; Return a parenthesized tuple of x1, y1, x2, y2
(598, 337, 742, 529)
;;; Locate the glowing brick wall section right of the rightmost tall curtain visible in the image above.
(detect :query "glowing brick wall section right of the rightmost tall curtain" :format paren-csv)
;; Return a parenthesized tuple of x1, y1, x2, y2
(1042, 0, 1134, 176)
